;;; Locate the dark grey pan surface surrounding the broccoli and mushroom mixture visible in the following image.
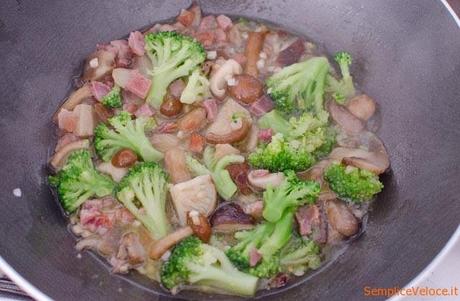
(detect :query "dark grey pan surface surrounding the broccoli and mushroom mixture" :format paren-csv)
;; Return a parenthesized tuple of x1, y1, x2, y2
(0, 0, 460, 300)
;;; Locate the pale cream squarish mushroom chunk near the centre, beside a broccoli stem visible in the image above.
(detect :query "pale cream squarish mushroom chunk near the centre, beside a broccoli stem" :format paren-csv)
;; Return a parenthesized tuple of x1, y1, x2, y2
(170, 175, 217, 225)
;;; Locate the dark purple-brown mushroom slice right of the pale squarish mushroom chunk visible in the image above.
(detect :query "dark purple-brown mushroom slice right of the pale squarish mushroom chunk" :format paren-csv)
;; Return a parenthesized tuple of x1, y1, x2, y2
(211, 203, 254, 233)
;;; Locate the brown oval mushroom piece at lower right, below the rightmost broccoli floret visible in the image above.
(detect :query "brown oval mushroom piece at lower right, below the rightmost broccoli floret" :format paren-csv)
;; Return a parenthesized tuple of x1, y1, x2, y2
(326, 200, 359, 237)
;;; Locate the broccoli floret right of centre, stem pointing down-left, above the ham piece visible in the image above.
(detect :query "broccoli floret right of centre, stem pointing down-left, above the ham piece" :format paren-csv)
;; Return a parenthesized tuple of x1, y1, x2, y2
(263, 171, 321, 222)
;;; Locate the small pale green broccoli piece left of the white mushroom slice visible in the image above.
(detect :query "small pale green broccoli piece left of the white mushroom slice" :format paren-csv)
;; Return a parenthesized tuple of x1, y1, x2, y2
(180, 68, 211, 104)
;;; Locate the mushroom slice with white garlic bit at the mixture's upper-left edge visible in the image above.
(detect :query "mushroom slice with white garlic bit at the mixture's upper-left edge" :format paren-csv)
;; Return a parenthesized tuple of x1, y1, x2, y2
(83, 49, 115, 81)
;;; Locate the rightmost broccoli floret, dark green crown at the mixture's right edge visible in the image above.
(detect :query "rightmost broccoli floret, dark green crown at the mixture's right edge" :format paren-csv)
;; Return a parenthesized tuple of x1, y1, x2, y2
(324, 164, 383, 203)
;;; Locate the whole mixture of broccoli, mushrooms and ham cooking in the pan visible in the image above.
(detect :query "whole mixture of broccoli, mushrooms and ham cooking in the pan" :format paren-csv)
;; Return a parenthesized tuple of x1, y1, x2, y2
(49, 5, 389, 296)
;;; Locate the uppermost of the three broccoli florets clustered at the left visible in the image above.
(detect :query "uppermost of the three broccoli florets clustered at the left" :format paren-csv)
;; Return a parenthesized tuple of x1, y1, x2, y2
(94, 111, 163, 161)
